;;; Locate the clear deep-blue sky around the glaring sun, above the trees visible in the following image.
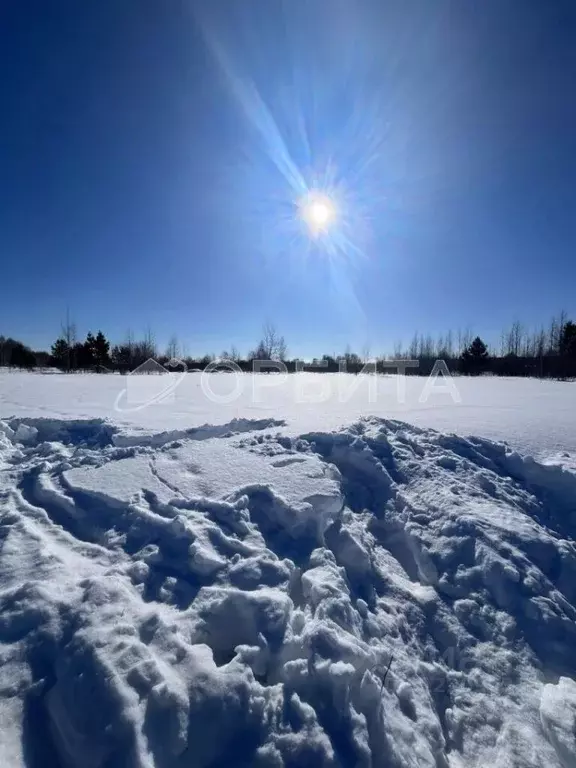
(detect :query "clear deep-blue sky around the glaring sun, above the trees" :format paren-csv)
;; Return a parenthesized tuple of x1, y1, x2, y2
(0, 0, 576, 356)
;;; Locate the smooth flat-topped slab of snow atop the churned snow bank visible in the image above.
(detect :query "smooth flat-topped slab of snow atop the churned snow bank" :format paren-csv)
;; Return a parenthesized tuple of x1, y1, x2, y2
(62, 432, 343, 534)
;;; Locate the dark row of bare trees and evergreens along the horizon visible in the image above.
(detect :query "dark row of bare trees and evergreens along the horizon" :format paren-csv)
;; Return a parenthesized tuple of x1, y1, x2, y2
(0, 313, 576, 378)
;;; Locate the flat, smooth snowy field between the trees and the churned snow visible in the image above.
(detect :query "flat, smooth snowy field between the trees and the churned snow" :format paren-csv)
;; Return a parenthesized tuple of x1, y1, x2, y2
(0, 372, 576, 456)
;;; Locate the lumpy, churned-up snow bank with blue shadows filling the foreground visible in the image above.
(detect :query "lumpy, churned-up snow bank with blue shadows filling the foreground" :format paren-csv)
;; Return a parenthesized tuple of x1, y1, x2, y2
(0, 418, 576, 768)
